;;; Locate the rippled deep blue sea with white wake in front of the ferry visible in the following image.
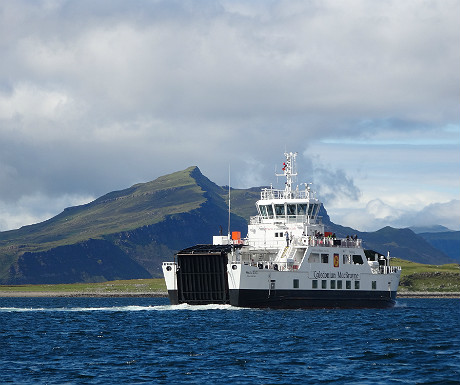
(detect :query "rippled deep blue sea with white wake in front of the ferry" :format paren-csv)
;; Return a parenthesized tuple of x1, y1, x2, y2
(0, 298, 460, 385)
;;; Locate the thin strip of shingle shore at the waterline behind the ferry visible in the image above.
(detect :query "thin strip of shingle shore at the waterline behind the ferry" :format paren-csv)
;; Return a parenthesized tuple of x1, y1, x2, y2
(0, 290, 460, 298)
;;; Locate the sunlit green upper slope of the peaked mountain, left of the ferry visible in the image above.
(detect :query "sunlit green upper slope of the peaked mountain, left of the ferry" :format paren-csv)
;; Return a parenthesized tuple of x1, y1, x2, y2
(0, 167, 205, 276)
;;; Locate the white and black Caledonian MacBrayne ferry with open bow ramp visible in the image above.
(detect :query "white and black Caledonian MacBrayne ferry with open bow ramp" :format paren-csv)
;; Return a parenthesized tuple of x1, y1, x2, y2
(162, 152, 401, 309)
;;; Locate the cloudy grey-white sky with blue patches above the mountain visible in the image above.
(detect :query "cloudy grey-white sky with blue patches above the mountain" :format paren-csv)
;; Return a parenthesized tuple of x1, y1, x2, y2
(0, 0, 460, 231)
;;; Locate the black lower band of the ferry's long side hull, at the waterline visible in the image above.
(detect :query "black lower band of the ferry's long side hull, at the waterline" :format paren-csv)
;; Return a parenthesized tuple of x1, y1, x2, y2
(229, 289, 396, 309)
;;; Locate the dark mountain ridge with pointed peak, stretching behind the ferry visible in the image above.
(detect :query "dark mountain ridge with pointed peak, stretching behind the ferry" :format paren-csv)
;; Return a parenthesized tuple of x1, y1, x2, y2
(0, 166, 453, 284)
